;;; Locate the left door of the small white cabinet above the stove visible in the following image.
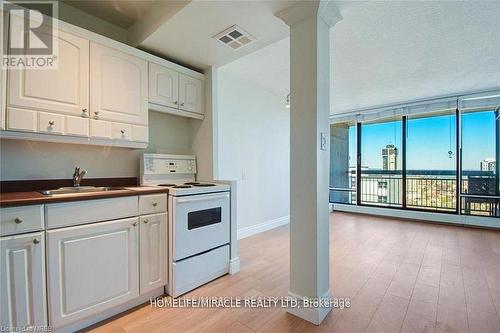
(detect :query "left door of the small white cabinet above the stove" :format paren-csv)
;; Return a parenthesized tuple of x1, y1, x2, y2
(149, 62, 179, 108)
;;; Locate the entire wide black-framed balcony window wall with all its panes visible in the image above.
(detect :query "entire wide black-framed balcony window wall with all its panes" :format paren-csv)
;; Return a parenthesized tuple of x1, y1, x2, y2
(330, 92, 500, 221)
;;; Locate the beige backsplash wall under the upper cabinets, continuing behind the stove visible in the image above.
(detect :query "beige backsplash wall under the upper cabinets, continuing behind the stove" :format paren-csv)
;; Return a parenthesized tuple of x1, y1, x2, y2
(0, 112, 191, 180)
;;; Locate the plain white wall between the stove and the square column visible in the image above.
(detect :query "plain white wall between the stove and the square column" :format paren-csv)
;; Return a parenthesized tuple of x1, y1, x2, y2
(217, 67, 290, 236)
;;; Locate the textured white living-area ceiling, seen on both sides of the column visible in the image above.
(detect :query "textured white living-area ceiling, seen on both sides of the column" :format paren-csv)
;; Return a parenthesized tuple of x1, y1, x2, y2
(223, 1, 500, 113)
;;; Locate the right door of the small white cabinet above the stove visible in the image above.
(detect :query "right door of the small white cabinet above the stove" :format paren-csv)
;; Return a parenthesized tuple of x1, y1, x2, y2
(179, 74, 204, 113)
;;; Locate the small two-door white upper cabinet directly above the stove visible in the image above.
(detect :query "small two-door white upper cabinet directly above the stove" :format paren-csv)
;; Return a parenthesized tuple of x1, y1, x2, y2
(149, 62, 204, 119)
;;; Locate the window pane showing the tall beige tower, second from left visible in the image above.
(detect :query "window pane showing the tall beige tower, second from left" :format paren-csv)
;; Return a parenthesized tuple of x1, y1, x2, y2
(359, 117, 403, 207)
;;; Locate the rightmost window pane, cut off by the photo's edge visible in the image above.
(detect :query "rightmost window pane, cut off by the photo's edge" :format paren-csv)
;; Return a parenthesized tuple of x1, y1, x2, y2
(460, 107, 500, 217)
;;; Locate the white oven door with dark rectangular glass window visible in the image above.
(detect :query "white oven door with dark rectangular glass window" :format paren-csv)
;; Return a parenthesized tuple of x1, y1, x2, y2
(172, 192, 230, 261)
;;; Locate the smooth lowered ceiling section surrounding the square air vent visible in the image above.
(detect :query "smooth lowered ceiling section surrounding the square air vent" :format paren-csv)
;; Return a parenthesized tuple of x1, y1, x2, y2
(139, 0, 295, 69)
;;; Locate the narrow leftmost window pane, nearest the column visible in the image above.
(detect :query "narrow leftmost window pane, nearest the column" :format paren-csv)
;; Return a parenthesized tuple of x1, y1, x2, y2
(330, 123, 357, 204)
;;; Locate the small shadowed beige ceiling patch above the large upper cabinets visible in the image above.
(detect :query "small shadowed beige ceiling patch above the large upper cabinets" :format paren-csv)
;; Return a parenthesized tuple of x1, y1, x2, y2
(63, 0, 158, 29)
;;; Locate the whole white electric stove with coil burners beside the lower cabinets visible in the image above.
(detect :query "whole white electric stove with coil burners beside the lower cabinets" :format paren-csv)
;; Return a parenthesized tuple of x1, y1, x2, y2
(140, 154, 230, 297)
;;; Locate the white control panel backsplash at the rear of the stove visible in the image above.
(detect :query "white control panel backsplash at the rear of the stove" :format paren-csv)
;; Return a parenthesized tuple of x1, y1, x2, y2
(142, 154, 196, 175)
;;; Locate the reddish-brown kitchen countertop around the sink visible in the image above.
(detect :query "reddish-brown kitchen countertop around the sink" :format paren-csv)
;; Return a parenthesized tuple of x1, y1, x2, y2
(0, 186, 168, 207)
